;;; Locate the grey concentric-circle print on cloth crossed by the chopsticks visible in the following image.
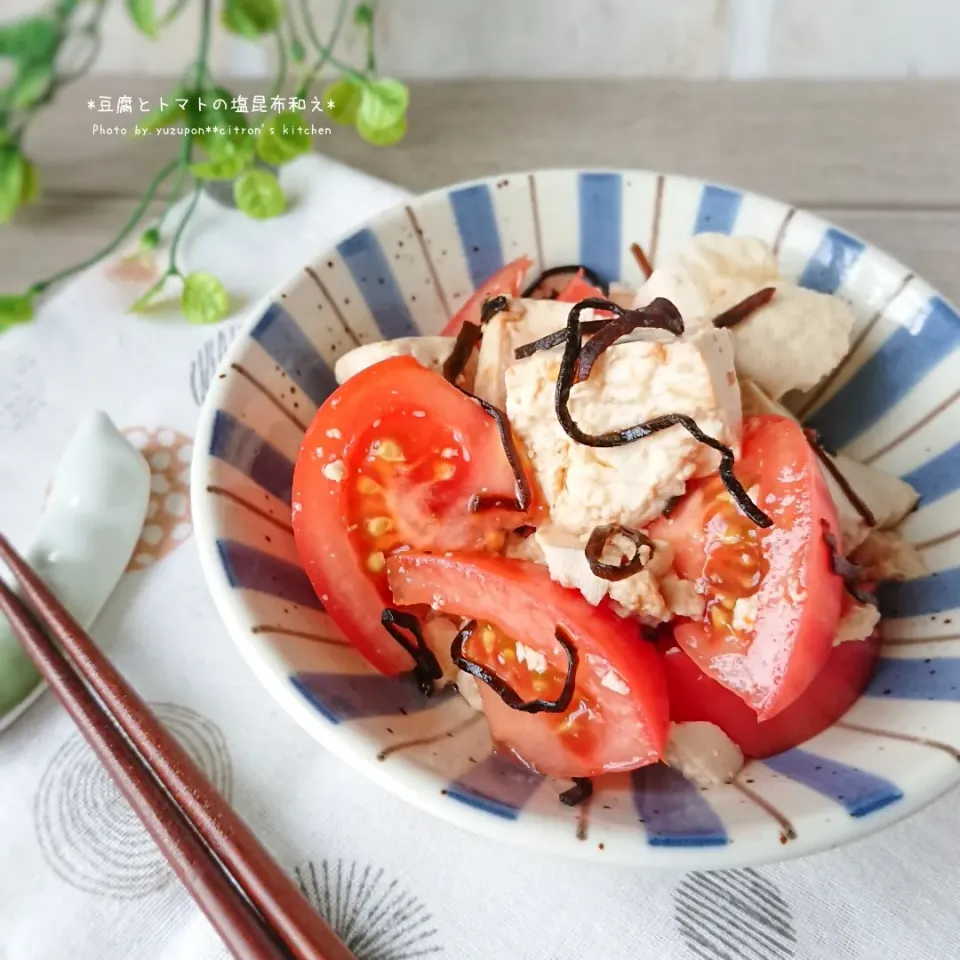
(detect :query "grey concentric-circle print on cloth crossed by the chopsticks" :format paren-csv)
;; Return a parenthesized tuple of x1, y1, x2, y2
(34, 703, 232, 900)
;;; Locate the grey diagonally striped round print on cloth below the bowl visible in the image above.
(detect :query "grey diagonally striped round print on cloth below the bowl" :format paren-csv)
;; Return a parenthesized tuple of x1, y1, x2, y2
(674, 868, 797, 960)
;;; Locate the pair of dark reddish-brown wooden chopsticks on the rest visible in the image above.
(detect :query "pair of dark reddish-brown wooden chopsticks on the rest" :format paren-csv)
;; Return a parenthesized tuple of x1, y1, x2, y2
(0, 535, 356, 960)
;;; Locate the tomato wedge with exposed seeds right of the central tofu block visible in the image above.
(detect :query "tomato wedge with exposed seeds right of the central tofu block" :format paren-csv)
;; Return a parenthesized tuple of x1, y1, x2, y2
(650, 416, 843, 720)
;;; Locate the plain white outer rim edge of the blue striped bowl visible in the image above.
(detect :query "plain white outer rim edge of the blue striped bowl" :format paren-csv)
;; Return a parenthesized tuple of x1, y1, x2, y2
(190, 166, 960, 869)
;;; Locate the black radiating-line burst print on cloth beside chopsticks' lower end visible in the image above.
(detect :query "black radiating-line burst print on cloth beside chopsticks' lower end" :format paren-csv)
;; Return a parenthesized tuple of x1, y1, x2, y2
(294, 860, 442, 960)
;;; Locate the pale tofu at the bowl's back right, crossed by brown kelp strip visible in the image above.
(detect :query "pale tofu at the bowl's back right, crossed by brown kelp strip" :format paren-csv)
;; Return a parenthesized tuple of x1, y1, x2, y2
(636, 233, 853, 397)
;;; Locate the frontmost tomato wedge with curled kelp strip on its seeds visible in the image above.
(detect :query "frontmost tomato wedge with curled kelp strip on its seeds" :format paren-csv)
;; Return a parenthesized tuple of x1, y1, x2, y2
(387, 553, 668, 777)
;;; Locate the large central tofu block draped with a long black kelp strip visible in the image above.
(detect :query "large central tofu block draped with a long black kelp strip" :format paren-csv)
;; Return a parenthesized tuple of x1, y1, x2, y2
(506, 330, 740, 535)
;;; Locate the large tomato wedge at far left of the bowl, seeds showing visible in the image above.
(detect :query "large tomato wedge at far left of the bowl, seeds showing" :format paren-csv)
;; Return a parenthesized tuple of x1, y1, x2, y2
(293, 357, 529, 674)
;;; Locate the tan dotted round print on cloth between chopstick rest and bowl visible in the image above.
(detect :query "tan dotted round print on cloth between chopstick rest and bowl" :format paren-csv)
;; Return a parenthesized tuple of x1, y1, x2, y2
(121, 427, 193, 571)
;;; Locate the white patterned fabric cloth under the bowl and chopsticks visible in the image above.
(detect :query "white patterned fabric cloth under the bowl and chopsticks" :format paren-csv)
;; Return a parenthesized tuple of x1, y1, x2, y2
(0, 157, 960, 960)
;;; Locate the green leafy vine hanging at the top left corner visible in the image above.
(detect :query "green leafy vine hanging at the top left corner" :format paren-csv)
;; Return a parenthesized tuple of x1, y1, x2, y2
(0, 0, 410, 332)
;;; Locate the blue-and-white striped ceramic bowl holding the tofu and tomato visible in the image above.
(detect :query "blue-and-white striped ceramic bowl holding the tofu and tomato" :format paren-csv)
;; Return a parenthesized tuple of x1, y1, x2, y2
(193, 170, 960, 868)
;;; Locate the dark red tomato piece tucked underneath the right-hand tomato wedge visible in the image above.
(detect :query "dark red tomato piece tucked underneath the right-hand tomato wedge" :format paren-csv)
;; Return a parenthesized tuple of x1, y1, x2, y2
(662, 633, 880, 757)
